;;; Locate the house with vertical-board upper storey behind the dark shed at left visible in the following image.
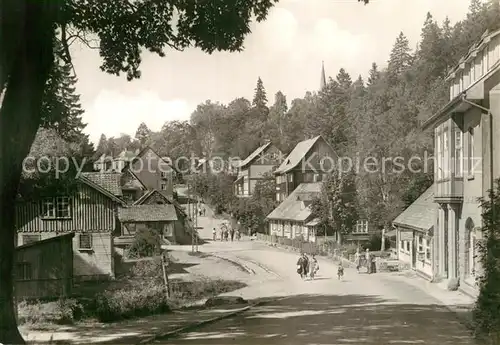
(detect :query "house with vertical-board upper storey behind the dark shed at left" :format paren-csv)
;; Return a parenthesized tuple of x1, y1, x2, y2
(15, 175, 123, 279)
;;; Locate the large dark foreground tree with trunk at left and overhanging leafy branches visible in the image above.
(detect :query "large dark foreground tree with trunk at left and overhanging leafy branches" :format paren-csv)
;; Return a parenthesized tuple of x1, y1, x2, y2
(0, 0, 286, 338)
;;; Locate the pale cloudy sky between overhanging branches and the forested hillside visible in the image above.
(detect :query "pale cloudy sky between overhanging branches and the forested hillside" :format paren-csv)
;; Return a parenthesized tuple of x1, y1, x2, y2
(71, 0, 470, 144)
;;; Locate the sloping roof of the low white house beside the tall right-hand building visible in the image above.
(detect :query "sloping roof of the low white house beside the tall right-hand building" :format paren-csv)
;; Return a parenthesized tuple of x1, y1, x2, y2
(392, 186, 436, 231)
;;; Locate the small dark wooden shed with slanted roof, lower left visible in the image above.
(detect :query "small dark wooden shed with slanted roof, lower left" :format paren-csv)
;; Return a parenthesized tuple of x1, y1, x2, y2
(14, 232, 75, 299)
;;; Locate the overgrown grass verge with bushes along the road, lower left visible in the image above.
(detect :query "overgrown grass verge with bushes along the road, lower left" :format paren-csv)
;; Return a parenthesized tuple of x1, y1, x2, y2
(18, 260, 246, 330)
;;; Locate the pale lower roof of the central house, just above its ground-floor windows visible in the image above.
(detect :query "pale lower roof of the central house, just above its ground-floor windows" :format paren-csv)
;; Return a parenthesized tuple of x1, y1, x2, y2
(266, 182, 322, 221)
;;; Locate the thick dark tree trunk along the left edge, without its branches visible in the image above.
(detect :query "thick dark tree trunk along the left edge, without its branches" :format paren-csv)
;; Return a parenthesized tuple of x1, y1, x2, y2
(0, 0, 58, 344)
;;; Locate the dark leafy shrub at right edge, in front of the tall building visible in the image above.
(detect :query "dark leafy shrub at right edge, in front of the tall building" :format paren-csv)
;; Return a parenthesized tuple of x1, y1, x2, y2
(473, 179, 500, 345)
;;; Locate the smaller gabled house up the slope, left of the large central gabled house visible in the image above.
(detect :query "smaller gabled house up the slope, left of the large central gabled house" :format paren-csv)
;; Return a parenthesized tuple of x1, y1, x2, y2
(233, 142, 283, 197)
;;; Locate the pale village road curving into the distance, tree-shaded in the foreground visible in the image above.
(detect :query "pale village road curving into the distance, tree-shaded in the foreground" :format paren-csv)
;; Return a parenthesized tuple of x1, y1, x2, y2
(156, 241, 473, 345)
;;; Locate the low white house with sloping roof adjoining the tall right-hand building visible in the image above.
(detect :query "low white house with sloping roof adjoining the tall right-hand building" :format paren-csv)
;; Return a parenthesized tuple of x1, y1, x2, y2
(393, 186, 437, 280)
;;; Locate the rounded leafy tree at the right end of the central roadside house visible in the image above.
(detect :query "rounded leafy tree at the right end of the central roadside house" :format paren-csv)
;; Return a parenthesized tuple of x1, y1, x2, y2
(311, 172, 358, 239)
